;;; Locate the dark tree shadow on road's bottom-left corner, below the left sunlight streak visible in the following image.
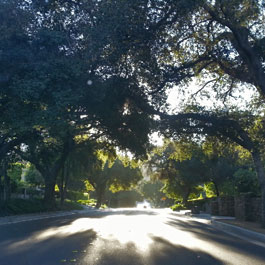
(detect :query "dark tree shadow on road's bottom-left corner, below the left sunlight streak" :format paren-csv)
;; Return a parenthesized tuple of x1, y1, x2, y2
(0, 226, 97, 265)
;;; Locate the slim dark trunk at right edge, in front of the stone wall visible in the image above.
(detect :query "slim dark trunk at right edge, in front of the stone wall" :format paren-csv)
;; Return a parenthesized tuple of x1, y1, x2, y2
(251, 152, 265, 227)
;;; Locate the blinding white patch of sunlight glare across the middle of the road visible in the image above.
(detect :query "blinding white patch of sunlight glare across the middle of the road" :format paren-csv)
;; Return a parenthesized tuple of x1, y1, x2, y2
(6, 209, 194, 252)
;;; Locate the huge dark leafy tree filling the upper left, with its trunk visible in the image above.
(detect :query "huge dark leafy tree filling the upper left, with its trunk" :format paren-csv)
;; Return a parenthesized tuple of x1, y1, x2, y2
(0, 0, 153, 204)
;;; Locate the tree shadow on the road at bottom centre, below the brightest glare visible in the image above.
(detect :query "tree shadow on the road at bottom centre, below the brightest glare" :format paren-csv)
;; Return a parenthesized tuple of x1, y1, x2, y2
(84, 237, 224, 265)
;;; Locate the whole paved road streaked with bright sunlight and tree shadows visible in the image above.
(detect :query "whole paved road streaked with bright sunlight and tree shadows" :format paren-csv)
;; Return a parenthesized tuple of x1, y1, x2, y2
(0, 209, 265, 265)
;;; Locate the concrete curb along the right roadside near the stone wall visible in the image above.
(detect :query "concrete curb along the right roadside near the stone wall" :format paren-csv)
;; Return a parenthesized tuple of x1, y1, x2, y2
(211, 219, 265, 247)
